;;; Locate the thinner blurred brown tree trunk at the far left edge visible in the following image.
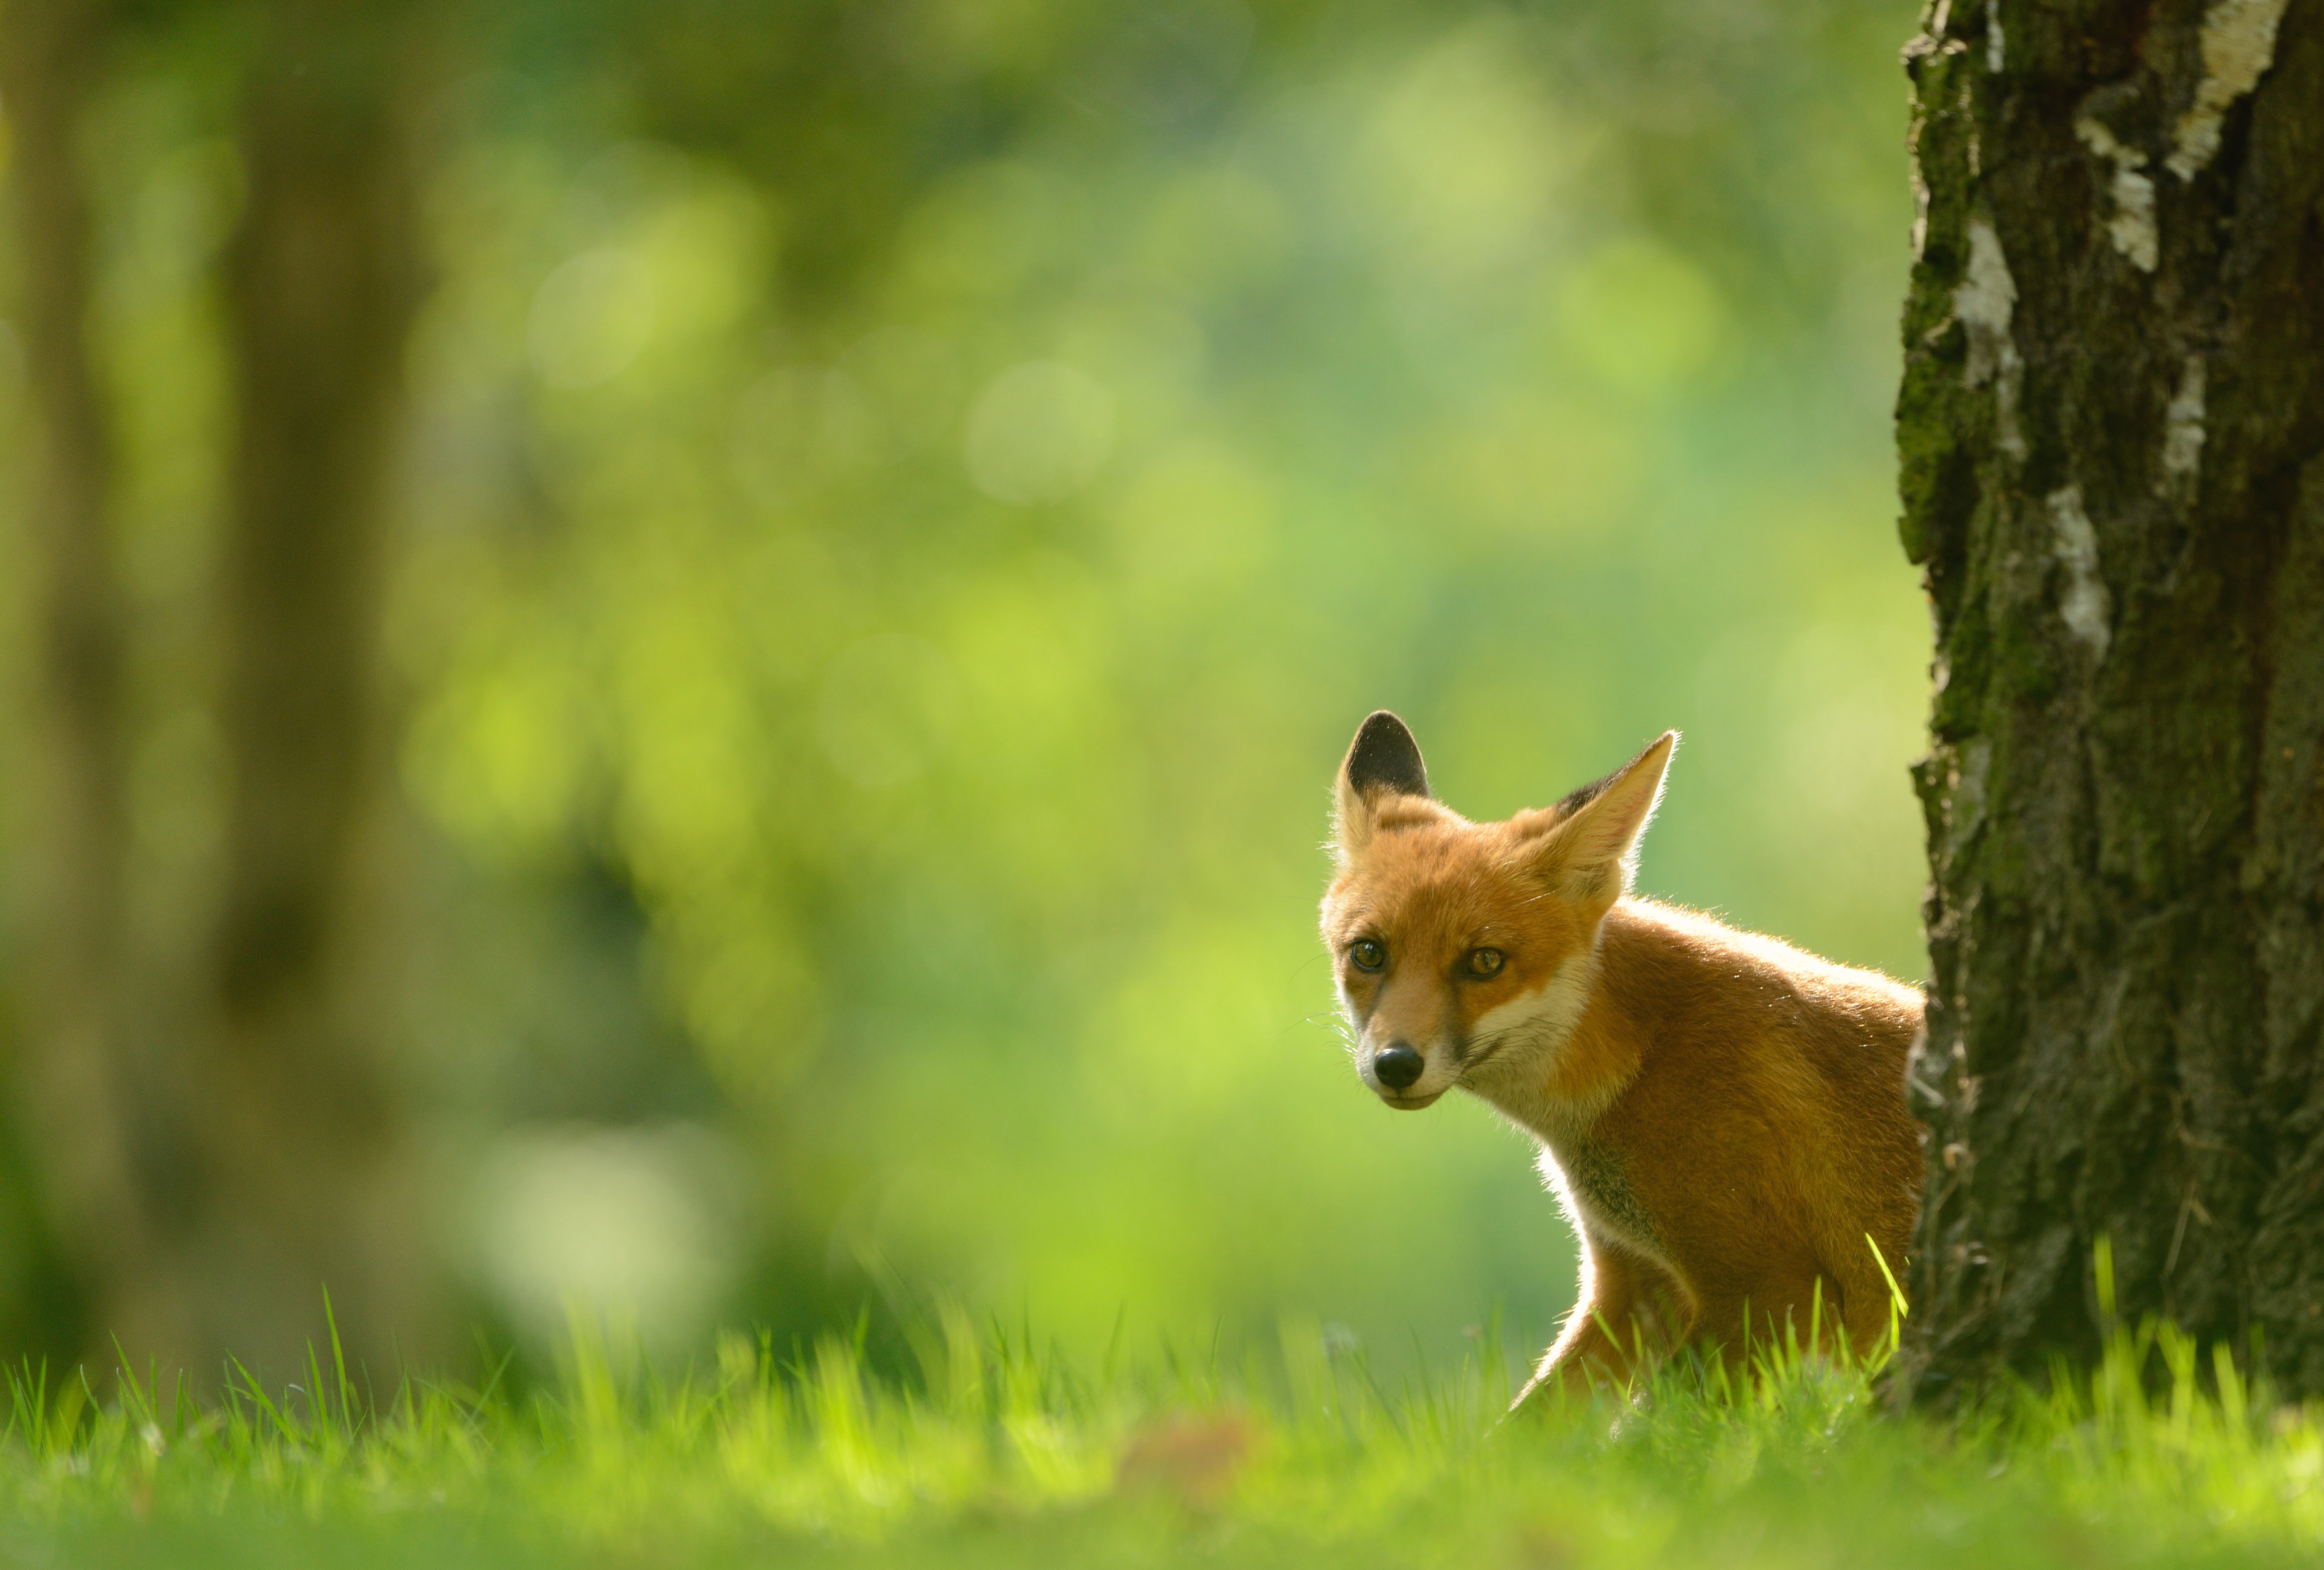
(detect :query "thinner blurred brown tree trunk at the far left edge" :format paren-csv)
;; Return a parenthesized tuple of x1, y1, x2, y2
(0, 0, 184, 1349)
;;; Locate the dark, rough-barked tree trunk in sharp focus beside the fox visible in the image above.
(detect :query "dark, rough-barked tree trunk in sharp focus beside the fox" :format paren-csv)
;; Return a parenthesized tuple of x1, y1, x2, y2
(1899, 0, 2324, 1400)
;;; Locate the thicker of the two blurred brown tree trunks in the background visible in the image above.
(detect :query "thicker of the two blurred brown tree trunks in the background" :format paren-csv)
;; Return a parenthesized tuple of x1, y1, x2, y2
(193, 0, 430, 1368)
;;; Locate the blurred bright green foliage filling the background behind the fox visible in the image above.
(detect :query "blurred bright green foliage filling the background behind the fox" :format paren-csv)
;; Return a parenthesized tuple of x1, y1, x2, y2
(0, 0, 1926, 1356)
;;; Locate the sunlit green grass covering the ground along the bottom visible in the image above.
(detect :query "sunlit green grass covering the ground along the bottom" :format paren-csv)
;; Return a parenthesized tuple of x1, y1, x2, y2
(0, 1312, 2324, 1570)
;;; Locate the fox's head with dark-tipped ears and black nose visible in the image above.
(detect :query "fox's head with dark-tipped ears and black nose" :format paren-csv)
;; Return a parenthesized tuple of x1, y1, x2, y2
(1323, 708, 1678, 1110)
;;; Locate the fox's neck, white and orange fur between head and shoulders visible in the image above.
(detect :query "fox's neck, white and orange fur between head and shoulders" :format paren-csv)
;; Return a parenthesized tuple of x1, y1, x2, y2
(1462, 922, 1638, 1145)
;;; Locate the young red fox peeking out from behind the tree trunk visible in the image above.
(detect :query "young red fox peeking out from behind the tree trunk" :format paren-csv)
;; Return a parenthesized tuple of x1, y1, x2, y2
(1323, 711, 1922, 1405)
